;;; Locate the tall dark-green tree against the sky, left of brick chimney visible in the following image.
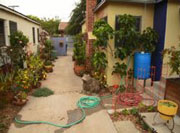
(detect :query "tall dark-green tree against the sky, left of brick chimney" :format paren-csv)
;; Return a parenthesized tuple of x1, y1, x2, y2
(66, 0, 86, 35)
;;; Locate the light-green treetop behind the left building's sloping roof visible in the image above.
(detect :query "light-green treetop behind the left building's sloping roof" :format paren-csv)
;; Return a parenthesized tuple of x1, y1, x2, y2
(28, 15, 60, 35)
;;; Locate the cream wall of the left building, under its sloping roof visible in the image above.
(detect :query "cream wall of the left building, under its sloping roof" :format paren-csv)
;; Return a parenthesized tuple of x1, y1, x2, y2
(0, 10, 41, 52)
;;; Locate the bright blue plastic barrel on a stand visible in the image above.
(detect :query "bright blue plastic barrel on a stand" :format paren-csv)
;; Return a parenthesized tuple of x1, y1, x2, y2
(134, 52, 151, 79)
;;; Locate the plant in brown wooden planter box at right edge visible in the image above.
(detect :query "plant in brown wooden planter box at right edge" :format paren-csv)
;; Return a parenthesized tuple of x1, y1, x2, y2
(163, 46, 180, 115)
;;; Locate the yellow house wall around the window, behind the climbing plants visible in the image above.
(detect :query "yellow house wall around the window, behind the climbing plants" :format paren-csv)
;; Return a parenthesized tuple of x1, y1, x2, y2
(96, 2, 154, 85)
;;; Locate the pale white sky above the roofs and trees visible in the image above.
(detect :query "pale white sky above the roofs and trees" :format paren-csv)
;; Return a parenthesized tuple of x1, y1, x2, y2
(0, 0, 80, 22)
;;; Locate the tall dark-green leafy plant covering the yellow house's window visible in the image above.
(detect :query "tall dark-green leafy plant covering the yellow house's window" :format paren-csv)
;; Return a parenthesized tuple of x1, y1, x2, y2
(115, 14, 139, 57)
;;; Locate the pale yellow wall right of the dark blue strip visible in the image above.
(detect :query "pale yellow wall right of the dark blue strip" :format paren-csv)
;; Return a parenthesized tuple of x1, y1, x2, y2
(163, 0, 180, 77)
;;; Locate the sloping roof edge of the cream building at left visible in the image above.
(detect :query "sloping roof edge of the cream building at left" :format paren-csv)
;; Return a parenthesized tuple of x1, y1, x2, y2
(0, 4, 40, 25)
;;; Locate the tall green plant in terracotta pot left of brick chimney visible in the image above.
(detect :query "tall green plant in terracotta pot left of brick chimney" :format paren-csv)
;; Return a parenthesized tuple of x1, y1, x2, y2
(73, 35, 86, 76)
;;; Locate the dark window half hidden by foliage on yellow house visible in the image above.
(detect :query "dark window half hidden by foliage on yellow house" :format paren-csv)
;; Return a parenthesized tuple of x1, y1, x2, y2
(115, 16, 142, 47)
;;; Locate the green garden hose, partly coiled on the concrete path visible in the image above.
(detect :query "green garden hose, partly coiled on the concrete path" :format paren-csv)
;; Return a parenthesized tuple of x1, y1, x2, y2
(15, 96, 101, 128)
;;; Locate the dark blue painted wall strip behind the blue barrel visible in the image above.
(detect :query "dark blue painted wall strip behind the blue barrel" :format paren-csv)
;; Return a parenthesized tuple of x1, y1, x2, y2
(152, 0, 168, 81)
